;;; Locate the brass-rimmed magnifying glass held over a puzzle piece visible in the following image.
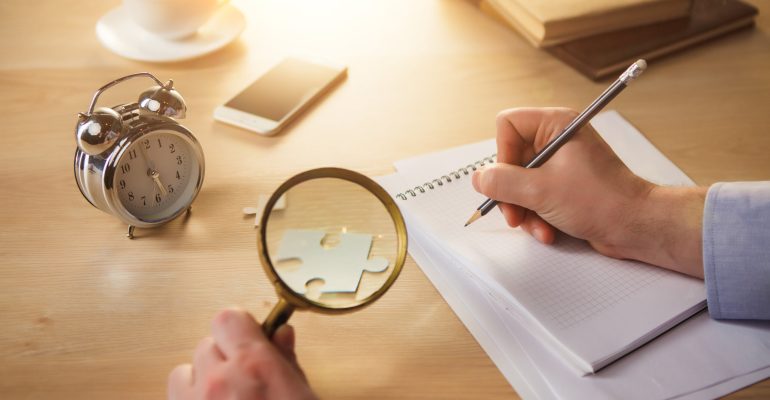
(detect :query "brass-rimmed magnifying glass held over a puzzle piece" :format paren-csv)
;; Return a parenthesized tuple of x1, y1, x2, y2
(257, 168, 407, 337)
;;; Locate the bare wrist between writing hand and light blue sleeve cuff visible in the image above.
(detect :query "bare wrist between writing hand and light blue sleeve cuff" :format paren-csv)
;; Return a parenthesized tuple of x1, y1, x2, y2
(623, 186, 707, 278)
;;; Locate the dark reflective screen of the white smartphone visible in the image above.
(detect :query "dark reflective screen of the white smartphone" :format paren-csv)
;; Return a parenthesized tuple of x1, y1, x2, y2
(225, 58, 342, 121)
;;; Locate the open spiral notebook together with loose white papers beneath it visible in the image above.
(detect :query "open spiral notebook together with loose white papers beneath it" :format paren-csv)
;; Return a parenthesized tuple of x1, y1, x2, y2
(380, 113, 770, 398)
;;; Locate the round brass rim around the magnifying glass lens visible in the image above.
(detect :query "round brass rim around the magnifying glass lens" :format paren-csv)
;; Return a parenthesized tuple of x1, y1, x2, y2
(257, 168, 407, 314)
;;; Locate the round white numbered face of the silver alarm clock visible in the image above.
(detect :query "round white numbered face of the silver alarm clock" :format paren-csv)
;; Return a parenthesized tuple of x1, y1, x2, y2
(113, 130, 200, 222)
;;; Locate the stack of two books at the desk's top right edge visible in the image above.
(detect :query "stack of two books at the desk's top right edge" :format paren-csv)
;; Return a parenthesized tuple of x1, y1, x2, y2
(479, 0, 757, 80)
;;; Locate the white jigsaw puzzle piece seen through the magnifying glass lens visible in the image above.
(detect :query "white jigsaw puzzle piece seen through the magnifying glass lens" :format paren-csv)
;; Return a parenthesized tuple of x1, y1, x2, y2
(275, 229, 388, 294)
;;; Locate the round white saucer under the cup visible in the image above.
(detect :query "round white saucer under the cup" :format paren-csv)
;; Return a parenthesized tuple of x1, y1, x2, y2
(96, 4, 246, 62)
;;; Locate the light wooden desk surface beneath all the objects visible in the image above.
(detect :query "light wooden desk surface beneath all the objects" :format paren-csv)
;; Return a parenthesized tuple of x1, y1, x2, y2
(0, 0, 770, 399)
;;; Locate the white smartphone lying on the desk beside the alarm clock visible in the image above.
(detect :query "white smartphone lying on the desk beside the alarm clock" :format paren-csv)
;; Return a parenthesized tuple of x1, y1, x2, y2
(214, 58, 347, 135)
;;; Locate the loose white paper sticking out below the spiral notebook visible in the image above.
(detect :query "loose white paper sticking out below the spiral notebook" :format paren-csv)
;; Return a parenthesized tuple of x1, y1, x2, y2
(402, 220, 770, 399)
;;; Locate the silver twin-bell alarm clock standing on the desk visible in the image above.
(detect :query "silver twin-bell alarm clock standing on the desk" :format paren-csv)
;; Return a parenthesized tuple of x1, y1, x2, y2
(75, 72, 204, 238)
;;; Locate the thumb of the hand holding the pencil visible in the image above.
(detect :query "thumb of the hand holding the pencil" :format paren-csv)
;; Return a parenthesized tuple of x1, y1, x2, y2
(472, 163, 544, 211)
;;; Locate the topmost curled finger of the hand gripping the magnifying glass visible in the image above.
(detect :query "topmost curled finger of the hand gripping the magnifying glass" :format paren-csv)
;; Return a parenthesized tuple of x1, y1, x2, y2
(211, 309, 267, 359)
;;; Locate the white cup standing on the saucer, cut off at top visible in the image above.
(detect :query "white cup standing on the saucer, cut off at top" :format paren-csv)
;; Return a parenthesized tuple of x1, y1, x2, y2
(123, 0, 227, 40)
